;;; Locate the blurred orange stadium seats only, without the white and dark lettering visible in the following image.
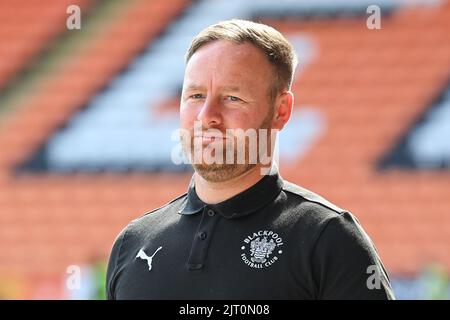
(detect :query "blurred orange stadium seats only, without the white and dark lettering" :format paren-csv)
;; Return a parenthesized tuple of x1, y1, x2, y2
(0, 0, 450, 297)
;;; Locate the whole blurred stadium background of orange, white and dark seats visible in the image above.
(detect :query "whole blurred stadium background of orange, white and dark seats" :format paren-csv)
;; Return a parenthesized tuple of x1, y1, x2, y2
(0, 0, 450, 299)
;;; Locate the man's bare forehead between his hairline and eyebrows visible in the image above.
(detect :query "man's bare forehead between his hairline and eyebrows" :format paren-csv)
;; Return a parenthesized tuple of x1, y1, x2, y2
(185, 40, 273, 86)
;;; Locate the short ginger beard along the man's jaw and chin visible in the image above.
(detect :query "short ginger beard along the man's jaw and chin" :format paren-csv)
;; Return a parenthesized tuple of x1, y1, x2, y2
(181, 107, 274, 182)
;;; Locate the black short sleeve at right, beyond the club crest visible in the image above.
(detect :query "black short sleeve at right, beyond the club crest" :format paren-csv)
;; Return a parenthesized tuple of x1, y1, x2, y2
(312, 212, 394, 300)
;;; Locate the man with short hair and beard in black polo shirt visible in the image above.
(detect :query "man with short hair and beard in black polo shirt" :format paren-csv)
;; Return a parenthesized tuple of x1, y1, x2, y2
(107, 20, 393, 299)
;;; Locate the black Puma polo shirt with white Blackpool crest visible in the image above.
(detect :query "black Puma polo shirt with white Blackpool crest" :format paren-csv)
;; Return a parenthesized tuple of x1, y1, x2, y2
(106, 172, 393, 300)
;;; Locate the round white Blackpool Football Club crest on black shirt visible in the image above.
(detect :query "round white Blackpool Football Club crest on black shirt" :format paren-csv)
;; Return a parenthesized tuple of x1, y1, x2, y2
(241, 230, 283, 269)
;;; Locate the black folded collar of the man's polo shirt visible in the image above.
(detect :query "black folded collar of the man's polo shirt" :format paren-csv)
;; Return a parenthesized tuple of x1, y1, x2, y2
(178, 166, 283, 219)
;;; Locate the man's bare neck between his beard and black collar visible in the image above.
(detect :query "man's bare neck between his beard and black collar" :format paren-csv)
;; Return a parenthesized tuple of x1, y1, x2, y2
(194, 165, 270, 204)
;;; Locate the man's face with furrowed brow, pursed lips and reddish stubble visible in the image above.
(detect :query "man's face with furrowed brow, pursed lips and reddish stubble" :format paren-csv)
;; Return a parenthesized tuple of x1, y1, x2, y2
(180, 41, 273, 182)
